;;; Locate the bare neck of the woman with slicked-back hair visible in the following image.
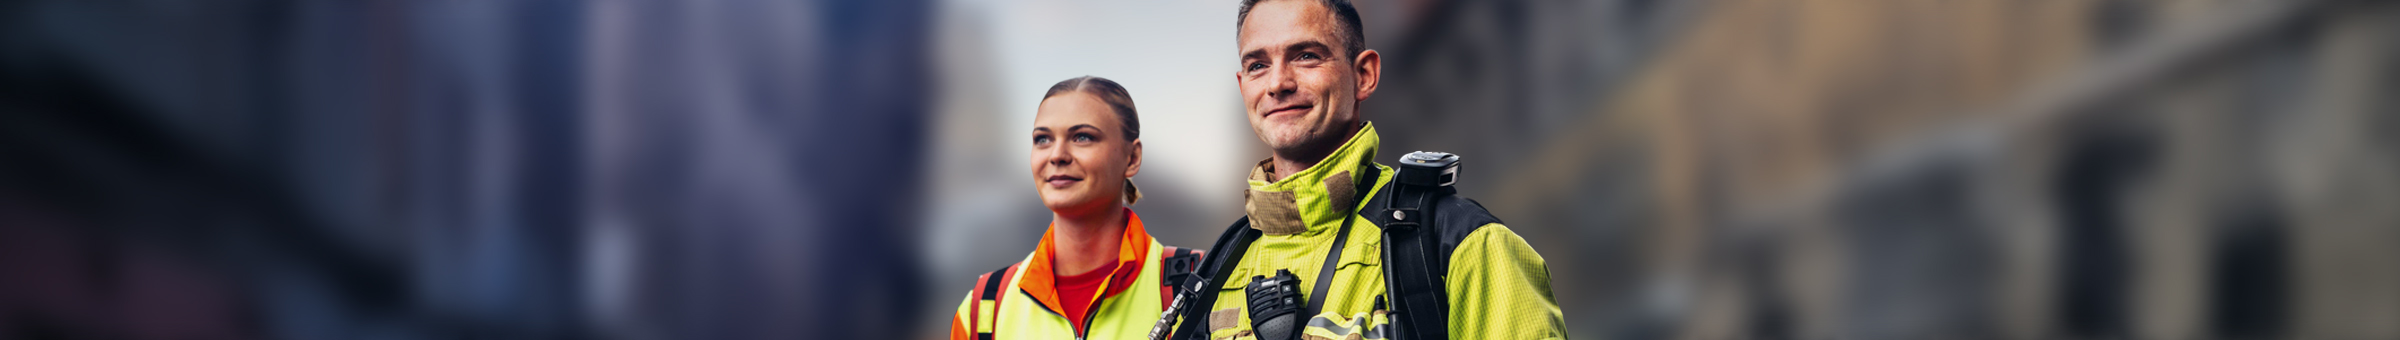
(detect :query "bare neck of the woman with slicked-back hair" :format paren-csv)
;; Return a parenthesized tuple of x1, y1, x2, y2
(1051, 206, 1126, 275)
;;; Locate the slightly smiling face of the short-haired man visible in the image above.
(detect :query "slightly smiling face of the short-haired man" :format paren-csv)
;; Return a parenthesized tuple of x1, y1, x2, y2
(1234, 0, 1373, 156)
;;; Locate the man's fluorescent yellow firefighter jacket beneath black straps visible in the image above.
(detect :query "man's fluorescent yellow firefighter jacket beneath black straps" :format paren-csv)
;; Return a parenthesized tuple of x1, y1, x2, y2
(1186, 125, 1567, 340)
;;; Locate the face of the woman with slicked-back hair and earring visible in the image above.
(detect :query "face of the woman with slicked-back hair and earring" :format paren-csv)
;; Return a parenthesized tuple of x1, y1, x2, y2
(1027, 91, 1142, 215)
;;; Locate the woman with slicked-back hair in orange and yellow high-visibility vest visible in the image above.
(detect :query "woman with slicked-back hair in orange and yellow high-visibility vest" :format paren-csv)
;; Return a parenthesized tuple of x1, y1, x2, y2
(950, 77, 1200, 340)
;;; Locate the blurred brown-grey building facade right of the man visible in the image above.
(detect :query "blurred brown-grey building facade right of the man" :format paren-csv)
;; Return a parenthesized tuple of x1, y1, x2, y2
(1363, 0, 2400, 338)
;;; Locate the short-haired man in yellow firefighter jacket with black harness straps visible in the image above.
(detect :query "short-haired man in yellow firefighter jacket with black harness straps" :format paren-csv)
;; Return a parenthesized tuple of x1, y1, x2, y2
(1174, 0, 1565, 340)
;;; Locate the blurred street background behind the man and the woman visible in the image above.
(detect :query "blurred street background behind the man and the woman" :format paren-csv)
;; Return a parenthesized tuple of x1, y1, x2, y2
(0, 0, 2400, 340)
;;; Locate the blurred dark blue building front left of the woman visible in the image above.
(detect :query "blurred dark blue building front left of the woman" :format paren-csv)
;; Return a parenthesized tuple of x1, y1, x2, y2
(0, 0, 931, 338)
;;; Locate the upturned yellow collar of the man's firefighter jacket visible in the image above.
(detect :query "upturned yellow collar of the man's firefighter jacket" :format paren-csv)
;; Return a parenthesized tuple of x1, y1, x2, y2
(1243, 122, 1390, 235)
